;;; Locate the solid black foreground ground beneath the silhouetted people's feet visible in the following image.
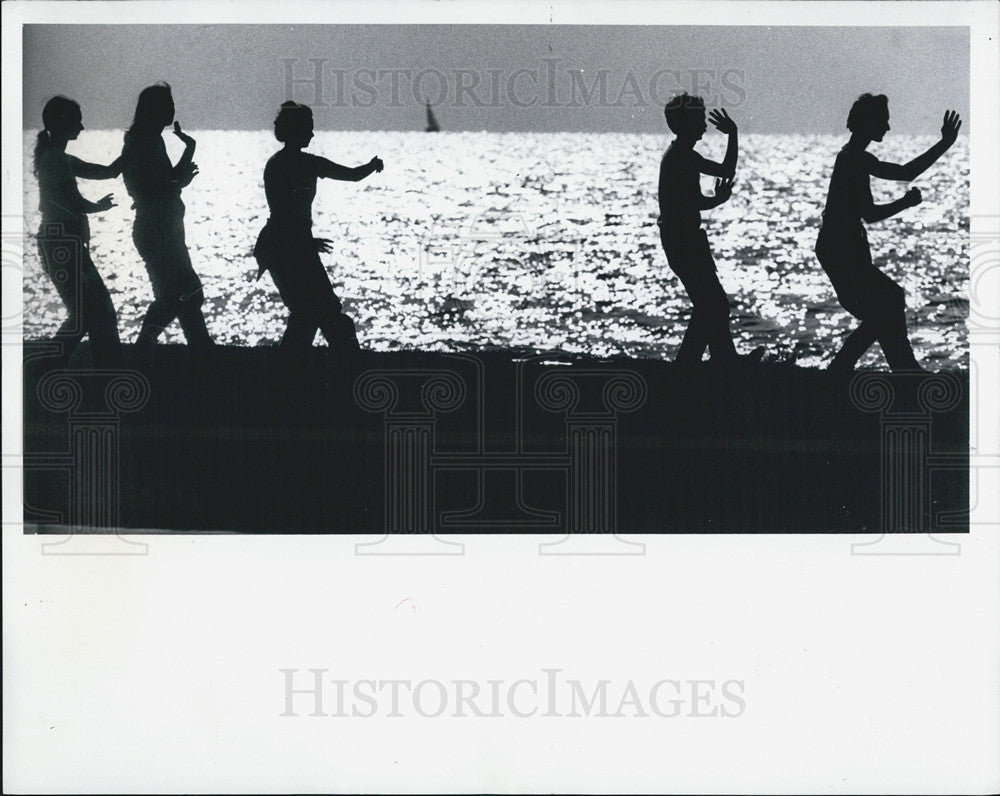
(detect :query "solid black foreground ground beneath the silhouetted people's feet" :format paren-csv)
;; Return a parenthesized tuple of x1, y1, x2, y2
(24, 342, 969, 534)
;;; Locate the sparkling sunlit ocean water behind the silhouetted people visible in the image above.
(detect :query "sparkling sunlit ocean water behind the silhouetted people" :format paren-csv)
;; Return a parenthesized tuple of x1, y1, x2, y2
(24, 130, 969, 369)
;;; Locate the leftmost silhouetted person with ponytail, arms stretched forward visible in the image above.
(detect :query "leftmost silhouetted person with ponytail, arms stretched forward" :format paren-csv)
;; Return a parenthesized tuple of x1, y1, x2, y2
(34, 97, 123, 369)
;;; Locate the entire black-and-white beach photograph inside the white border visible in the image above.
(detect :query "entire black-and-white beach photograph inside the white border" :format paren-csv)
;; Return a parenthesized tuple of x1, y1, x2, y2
(19, 24, 976, 534)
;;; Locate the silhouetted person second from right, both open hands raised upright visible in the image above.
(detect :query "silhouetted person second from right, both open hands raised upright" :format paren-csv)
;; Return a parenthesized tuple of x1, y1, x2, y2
(658, 92, 764, 369)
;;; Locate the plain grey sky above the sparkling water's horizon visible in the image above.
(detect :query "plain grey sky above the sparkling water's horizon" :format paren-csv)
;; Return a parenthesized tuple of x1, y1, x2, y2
(24, 25, 969, 134)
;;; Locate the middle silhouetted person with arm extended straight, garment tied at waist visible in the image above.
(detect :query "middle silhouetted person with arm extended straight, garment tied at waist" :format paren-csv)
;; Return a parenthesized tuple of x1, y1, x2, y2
(254, 101, 383, 370)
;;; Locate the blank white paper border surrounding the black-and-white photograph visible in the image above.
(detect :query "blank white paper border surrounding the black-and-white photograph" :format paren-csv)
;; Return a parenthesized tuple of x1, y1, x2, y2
(2, 0, 1000, 793)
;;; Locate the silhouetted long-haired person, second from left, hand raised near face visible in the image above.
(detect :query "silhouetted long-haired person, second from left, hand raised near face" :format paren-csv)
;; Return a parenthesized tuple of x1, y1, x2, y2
(122, 83, 213, 362)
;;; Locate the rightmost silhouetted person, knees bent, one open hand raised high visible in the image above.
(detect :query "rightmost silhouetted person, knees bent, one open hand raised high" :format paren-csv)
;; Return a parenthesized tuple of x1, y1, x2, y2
(816, 94, 962, 378)
